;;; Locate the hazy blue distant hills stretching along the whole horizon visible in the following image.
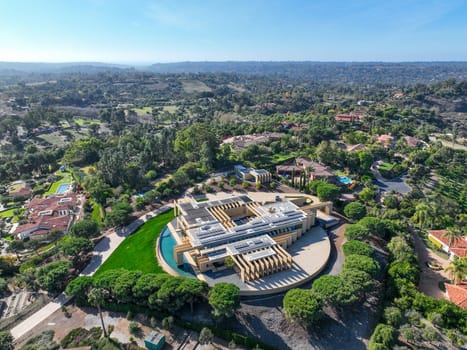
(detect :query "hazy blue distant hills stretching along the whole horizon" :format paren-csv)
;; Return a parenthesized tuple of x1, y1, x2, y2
(0, 61, 467, 85)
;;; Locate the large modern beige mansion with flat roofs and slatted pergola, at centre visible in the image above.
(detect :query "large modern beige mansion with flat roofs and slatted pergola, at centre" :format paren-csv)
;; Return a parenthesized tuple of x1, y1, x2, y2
(169, 196, 332, 282)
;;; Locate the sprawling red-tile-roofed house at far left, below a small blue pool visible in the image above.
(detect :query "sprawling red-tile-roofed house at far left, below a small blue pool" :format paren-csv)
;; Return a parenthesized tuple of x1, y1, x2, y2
(13, 193, 79, 240)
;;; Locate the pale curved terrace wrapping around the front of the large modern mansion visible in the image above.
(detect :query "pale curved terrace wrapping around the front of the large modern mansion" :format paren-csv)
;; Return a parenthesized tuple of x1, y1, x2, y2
(156, 226, 331, 296)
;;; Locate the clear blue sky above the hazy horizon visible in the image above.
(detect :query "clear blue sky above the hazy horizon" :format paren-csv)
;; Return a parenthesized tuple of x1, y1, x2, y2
(0, 0, 467, 63)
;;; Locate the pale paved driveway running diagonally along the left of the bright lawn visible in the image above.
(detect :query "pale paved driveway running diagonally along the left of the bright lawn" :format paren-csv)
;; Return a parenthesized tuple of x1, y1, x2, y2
(11, 205, 173, 340)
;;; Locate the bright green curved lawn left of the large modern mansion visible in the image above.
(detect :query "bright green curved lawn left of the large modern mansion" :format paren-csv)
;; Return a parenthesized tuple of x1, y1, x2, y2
(95, 210, 174, 276)
